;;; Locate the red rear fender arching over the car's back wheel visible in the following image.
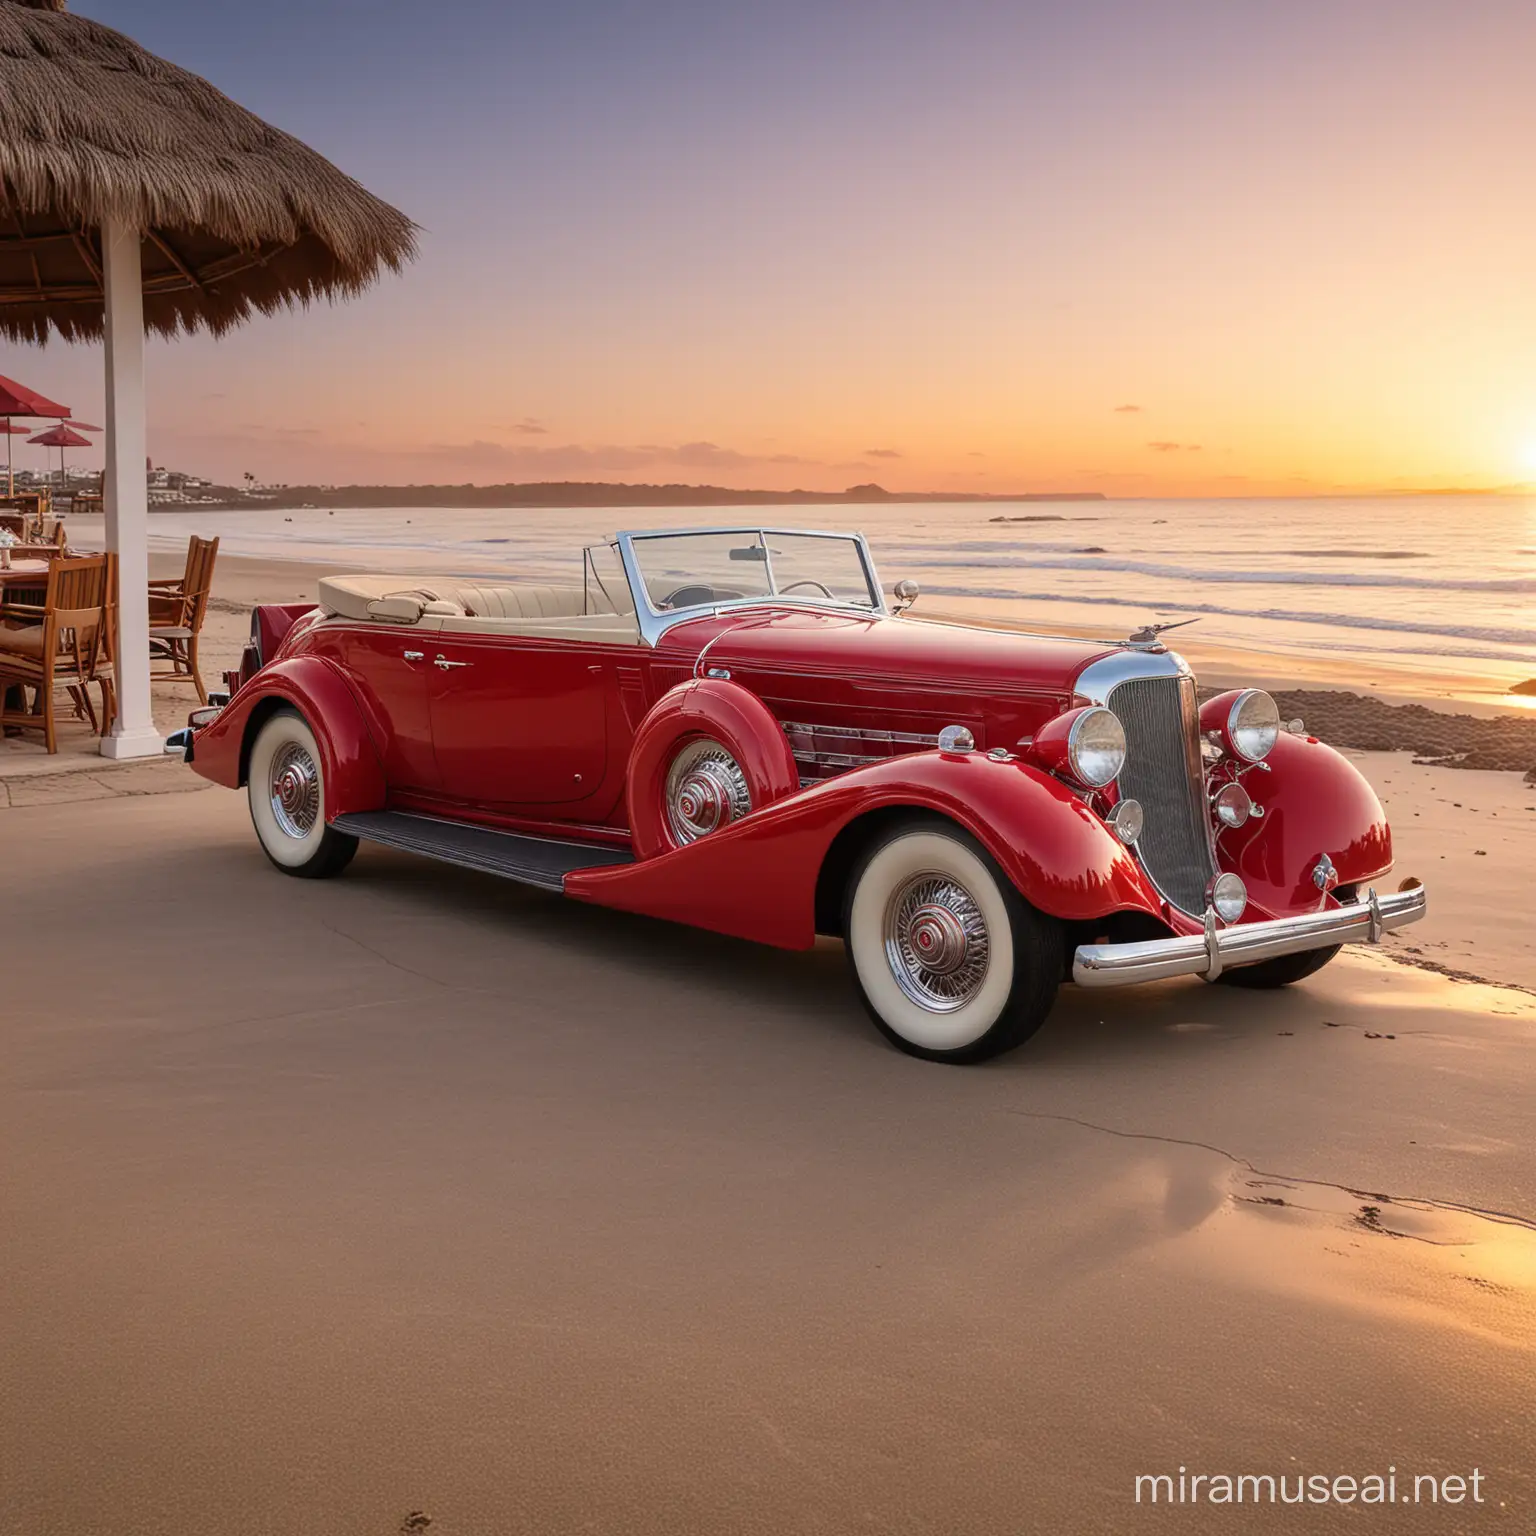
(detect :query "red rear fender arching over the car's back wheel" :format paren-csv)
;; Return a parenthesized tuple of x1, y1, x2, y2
(190, 656, 387, 822)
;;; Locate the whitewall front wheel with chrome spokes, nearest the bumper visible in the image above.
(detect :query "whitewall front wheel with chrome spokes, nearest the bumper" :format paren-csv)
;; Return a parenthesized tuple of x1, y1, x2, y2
(843, 819, 1063, 1063)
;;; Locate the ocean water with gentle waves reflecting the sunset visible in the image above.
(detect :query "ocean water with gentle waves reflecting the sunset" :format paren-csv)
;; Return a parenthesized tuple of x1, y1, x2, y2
(81, 496, 1536, 693)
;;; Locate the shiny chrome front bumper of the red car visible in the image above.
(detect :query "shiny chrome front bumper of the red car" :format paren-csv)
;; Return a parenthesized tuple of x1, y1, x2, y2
(1072, 885, 1428, 986)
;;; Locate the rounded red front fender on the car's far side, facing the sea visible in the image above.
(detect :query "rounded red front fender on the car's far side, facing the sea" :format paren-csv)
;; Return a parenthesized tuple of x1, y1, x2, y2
(1218, 733, 1392, 917)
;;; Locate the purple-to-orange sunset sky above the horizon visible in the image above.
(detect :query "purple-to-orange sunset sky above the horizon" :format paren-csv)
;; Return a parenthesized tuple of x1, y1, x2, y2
(9, 0, 1536, 495)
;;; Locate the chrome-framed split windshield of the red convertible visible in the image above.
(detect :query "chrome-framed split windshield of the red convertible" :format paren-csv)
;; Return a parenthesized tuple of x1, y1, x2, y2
(631, 528, 879, 613)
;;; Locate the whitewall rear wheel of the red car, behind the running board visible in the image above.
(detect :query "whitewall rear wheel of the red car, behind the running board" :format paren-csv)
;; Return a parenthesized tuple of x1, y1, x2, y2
(246, 707, 358, 880)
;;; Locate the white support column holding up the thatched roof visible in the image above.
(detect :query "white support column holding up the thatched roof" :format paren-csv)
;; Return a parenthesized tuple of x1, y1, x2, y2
(101, 220, 161, 757)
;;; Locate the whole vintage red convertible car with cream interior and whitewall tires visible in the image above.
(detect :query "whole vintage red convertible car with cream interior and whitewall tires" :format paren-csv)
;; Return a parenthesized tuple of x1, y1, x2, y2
(166, 528, 1425, 1061)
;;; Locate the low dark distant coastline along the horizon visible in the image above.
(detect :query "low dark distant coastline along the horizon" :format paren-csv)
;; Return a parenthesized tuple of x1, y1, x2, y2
(185, 481, 1106, 511)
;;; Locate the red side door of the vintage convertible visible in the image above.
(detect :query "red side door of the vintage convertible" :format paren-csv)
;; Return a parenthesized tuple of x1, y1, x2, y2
(425, 631, 614, 806)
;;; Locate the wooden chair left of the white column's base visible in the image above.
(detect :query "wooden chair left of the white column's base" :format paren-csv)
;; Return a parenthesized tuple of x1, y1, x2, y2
(0, 554, 115, 753)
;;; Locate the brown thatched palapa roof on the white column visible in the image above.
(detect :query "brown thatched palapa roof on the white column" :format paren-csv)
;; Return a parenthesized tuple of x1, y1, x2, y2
(0, 0, 415, 341)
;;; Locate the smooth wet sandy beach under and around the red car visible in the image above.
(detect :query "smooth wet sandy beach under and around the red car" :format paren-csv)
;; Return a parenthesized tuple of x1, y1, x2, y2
(0, 546, 1536, 1536)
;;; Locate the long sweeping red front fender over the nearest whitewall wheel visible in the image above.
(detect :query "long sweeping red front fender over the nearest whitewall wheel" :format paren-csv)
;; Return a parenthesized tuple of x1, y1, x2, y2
(565, 753, 1161, 949)
